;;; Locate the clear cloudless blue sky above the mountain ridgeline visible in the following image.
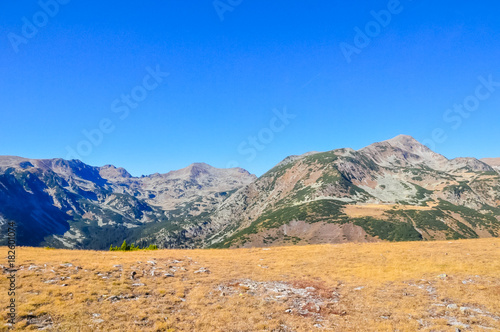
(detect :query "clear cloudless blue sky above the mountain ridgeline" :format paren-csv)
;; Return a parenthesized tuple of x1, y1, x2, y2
(0, 0, 500, 175)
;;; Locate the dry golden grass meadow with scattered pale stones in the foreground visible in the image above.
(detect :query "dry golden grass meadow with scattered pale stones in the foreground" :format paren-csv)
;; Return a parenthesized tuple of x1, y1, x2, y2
(0, 239, 500, 331)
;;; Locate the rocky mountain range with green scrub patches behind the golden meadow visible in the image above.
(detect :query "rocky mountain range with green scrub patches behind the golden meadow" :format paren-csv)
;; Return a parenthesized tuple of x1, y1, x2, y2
(0, 135, 500, 249)
